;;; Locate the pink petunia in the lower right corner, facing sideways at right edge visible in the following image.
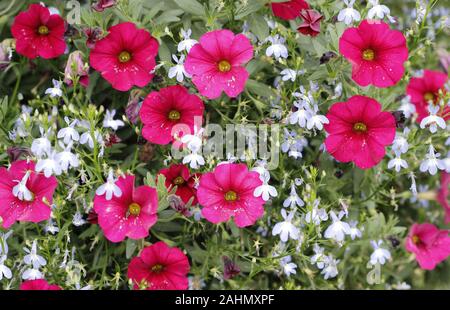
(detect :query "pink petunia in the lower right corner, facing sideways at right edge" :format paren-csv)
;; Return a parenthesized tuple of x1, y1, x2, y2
(406, 223, 450, 270)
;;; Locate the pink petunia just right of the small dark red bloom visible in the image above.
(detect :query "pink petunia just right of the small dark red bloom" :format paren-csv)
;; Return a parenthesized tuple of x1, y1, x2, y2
(197, 163, 264, 227)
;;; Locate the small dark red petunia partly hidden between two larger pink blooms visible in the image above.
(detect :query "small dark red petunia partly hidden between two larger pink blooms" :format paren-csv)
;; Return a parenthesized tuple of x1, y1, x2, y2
(159, 164, 200, 205)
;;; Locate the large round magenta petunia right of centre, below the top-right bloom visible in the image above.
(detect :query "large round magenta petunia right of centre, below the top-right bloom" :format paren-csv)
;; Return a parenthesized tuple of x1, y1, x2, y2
(324, 96, 396, 169)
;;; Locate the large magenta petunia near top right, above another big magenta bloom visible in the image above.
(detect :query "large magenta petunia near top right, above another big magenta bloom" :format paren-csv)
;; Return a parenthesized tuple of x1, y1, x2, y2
(339, 20, 408, 87)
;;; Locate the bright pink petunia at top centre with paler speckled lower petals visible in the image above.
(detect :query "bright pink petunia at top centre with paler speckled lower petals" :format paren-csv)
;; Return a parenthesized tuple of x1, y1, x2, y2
(184, 30, 253, 99)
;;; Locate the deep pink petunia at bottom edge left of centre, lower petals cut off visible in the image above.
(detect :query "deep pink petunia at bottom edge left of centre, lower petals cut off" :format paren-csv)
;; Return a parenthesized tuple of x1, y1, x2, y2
(128, 241, 190, 290)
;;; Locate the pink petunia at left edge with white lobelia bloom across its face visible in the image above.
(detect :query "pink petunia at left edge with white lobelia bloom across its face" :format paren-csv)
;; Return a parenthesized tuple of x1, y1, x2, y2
(0, 160, 58, 228)
